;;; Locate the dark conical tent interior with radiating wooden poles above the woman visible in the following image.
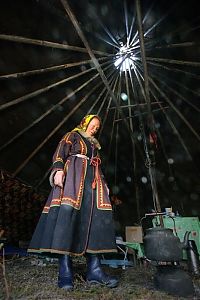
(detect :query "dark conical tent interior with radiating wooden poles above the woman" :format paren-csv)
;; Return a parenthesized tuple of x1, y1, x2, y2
(0, 0, 200, 225)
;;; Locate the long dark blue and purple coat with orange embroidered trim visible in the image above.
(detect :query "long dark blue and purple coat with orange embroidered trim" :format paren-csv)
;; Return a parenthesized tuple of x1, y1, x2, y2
(28, 131, 117, 255)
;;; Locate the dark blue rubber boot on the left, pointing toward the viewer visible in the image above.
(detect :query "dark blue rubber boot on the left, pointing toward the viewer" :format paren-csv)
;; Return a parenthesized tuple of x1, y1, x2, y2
(58, 255, 74, 290)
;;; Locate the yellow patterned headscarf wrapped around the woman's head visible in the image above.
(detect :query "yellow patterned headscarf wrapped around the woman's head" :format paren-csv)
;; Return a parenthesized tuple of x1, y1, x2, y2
(72, 115, 101, 150)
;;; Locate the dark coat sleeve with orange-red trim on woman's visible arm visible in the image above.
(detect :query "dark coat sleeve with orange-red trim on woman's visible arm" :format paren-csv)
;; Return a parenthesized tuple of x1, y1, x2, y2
(49, 132, 74, 186)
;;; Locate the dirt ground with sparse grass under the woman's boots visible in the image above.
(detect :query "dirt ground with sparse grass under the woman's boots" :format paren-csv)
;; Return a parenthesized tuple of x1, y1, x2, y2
(0, 256, 200, 300)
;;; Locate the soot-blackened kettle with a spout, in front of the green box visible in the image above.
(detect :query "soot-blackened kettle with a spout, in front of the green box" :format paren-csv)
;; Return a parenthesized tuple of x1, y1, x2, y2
(143, 227, 188, 262)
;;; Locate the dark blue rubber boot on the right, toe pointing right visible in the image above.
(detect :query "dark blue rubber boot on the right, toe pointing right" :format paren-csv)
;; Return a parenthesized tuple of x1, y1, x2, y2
(86, 254, 118, 288)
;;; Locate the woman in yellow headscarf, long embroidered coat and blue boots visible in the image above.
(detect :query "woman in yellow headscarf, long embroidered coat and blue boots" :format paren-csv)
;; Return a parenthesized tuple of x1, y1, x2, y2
(28, 115, 118, 290)
